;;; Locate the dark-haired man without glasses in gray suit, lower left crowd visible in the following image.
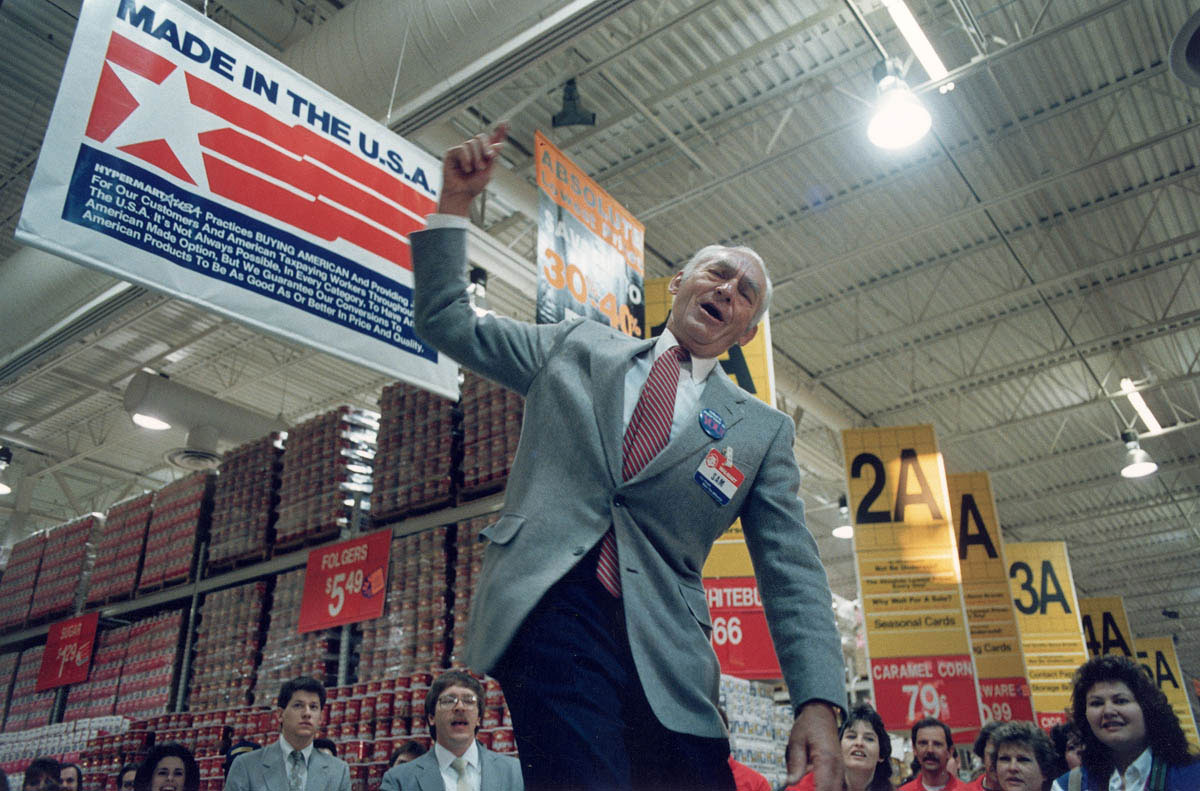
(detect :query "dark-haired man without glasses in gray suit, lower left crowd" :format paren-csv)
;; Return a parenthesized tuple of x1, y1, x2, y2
(224, 676, 350, 791)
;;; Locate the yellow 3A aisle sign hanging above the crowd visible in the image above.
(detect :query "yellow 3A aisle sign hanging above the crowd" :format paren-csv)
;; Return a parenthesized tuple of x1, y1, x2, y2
(1004, 541, 1087, 730)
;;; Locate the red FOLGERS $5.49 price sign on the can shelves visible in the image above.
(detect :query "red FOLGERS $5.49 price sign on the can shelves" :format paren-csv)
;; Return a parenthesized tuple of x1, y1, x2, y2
(300, 528, 391, 634)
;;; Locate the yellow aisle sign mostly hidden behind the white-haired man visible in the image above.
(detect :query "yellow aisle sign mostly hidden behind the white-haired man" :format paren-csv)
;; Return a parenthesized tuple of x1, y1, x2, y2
(646, 277, 775, 577)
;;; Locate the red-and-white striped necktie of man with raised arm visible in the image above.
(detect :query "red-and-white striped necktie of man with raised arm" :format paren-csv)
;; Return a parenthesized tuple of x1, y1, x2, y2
(596, 346, 689, 598)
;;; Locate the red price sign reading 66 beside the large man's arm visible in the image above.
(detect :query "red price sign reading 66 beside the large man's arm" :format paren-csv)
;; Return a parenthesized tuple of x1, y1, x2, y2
(704, 577, 784, 678)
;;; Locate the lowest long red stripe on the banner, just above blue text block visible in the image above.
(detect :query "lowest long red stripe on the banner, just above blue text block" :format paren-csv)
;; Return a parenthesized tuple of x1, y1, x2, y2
(204, 154, 413, 270)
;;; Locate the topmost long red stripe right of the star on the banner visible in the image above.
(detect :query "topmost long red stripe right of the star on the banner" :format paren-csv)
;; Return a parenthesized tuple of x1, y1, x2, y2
(187, 74, 437, 217)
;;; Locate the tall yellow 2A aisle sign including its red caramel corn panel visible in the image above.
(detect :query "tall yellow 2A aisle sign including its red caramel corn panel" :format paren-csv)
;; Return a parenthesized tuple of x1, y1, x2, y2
(842, 426, 980, 739)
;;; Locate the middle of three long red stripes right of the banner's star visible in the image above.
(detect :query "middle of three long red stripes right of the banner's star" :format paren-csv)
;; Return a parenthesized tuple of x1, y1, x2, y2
(199, 128, 425, 236)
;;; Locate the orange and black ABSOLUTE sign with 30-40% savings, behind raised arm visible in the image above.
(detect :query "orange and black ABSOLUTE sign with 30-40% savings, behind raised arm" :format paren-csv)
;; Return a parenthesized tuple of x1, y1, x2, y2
(534, 132, 646, 337)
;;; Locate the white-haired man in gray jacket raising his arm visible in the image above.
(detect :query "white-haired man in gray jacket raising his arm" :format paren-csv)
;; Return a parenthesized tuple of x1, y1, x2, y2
(410, 127, 845, 791)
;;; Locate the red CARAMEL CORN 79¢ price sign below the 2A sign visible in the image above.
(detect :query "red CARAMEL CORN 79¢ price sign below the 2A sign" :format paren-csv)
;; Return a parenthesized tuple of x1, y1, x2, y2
(871, 654, 979, 730)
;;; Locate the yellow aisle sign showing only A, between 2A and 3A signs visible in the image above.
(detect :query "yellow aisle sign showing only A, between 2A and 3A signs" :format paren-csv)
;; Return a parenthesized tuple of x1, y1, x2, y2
(946, 473, 1033, 721)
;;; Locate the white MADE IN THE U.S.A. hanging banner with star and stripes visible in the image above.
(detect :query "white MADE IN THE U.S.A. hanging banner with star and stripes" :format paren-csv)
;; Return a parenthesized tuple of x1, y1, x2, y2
(17, 0, 458, 397)
